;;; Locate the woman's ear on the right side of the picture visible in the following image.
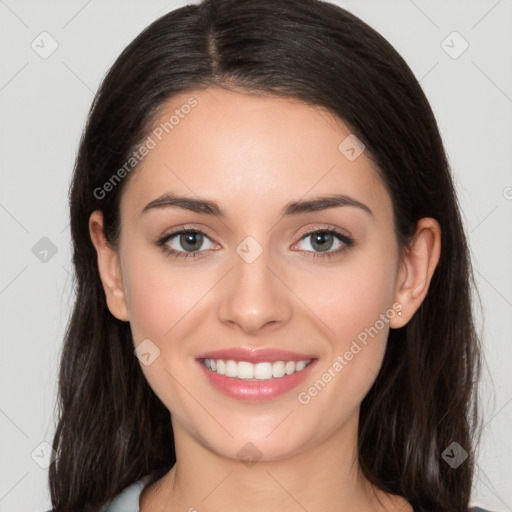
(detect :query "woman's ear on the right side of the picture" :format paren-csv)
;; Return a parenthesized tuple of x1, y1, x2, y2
(389, 217, 441, 329)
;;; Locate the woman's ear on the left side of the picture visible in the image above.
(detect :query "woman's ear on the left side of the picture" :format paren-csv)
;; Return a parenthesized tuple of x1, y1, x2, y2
(89, 210, 128, 321)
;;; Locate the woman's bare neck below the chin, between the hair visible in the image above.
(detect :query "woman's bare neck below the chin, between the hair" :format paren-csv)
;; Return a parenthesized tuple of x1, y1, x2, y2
(141, 417, 412, 512)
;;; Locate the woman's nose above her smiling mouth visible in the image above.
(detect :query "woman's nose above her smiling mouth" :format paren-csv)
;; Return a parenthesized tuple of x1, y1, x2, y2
(218, 244, 292, 335)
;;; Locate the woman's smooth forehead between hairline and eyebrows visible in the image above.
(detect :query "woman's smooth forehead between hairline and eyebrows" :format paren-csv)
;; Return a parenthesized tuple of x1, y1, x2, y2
(121, 88, 391, 224)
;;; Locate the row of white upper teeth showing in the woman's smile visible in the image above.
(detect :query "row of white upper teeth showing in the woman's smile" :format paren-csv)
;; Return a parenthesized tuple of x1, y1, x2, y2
(203, 359, 311, 380)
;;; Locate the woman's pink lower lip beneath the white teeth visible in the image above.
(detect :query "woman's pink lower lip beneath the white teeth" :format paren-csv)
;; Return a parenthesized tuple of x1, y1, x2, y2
(197, 359, 317, 402)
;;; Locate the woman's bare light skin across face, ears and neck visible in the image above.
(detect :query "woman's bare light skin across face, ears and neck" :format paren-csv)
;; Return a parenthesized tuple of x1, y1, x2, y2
(89, 88, 440, 512)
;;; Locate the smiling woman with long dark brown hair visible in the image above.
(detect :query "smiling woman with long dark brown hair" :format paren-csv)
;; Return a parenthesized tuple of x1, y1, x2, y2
(49, 0, 492, 512)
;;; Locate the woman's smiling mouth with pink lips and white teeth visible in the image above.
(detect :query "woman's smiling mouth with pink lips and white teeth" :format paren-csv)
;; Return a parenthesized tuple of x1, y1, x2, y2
(196, 348, 318, 402)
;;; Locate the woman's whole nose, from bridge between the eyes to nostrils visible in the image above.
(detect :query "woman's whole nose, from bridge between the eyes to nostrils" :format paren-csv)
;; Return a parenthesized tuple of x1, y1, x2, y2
(219, 236, 291, 333)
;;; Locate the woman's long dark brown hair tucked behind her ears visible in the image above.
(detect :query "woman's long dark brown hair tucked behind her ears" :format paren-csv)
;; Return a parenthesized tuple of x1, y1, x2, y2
(49, 0, 480, 512)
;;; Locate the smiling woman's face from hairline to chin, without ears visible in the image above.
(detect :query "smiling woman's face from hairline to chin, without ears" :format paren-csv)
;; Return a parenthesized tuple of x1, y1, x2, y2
(100, 89, 406, 460)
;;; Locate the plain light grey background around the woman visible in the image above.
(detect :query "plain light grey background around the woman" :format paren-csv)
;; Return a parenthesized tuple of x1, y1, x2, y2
(0, 0, 512, 512)
